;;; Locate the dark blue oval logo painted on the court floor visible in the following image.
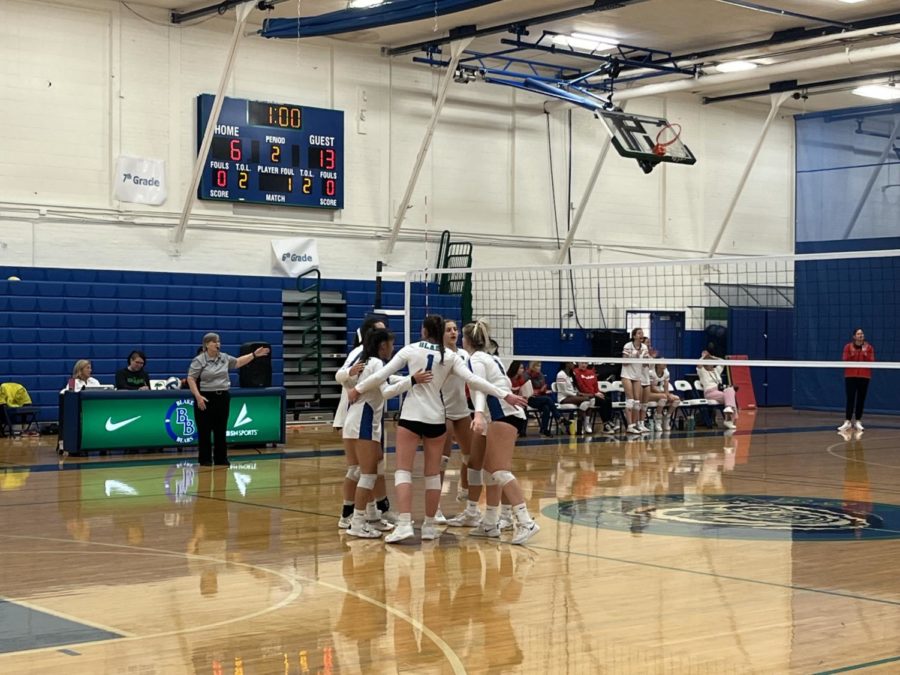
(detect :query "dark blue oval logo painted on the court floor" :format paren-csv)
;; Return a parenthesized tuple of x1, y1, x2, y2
(544, 495, 900, 541)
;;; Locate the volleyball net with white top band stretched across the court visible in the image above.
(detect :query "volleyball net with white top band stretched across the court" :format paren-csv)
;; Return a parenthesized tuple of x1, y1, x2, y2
(405, 250, 900, 412)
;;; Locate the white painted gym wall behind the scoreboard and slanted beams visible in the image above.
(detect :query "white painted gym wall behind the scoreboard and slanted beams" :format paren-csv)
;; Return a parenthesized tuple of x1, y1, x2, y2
(0, 0, 794, 278)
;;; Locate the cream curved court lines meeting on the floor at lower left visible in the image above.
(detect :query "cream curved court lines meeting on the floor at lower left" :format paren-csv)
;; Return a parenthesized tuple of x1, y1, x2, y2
(0, 533, 466, 675)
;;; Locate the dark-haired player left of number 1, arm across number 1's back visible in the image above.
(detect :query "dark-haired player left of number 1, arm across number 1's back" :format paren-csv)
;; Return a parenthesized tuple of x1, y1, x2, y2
(342, 329, 431, 538)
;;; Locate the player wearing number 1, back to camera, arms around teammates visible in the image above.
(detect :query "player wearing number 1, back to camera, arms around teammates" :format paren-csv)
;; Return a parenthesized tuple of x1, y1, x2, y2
(348, 314, 525, 543)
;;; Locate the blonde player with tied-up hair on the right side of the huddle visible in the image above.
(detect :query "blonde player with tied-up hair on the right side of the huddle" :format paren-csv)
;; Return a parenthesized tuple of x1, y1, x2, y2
(463, 320, 541, 544)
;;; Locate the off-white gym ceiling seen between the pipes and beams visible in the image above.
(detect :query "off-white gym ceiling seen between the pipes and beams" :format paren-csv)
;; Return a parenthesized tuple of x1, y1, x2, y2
(127, 0, 900, 110)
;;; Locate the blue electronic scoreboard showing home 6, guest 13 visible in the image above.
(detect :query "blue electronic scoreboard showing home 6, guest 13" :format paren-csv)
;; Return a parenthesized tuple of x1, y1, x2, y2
(197, 94, 344, 209)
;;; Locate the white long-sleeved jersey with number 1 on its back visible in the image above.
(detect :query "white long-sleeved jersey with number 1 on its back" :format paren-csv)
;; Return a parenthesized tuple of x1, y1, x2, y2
(356, 340, 509, 424)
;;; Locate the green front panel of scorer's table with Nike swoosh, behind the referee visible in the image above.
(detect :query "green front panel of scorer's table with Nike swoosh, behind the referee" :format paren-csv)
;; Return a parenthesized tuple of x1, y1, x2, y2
(80, 394, 282, 450)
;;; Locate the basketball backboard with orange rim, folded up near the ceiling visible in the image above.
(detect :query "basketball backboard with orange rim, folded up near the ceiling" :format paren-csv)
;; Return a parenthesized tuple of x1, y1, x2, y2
(597, 110, 697, 173)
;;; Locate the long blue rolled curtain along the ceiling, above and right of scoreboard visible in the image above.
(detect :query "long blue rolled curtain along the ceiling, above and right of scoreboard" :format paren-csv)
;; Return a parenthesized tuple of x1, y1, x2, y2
(259, 0, 500, 38)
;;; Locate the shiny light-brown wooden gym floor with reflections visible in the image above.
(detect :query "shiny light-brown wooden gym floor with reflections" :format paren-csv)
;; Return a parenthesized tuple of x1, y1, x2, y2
(0, 410, 900, 675)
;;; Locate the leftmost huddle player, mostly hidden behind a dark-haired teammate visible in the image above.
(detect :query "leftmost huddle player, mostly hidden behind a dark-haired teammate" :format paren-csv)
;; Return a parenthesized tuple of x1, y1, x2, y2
(332, 316, 391, 530)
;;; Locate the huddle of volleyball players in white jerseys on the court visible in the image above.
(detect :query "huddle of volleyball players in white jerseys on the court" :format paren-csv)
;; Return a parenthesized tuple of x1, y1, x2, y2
(334, 315, 540, 544)
